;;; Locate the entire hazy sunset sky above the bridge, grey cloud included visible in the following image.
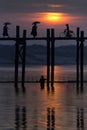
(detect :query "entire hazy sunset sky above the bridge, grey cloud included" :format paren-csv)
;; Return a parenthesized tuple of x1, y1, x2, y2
(0, 0, 87, 36)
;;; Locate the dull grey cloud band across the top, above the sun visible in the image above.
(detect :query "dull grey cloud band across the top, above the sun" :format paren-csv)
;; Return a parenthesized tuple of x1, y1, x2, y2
(0, 0, 87, 15)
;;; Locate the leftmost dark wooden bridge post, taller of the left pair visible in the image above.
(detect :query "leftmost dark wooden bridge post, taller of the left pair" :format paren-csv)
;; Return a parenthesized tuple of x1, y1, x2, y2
(15, 26, 20, 91)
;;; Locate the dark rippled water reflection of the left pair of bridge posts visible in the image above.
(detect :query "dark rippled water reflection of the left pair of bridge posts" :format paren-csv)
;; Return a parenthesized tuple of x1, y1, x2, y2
(15, 106, 27, 130)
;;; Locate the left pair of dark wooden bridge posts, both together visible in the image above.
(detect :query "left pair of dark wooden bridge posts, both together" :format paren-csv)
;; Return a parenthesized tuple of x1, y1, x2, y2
(15, 26, 26, 92)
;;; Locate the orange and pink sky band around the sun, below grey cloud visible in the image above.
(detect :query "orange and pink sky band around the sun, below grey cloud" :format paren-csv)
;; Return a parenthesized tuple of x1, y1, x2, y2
(0, 12, 86, 36)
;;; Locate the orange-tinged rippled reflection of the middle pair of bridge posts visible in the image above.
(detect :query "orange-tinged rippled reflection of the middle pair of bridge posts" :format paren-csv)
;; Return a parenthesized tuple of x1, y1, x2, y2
(47, 107, 55, 130)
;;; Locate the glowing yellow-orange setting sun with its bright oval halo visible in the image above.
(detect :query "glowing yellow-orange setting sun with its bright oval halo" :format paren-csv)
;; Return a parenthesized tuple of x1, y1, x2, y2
(22, 12, 75, 27)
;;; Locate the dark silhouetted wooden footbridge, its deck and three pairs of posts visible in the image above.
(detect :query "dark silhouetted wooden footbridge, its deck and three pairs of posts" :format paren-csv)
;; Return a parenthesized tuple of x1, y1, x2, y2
(0, 26, 87, 91)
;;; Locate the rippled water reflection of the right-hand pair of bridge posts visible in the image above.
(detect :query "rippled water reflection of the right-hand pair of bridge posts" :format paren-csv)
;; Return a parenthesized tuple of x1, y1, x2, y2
(77, 108, 84, 130)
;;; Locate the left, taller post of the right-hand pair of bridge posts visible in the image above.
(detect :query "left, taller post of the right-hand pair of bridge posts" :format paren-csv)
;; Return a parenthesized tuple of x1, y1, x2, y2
(76, 28, 80, 91)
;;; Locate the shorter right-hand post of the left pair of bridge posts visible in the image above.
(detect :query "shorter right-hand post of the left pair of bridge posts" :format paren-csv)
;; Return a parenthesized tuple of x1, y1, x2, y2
(22, 30, 26, 91)
